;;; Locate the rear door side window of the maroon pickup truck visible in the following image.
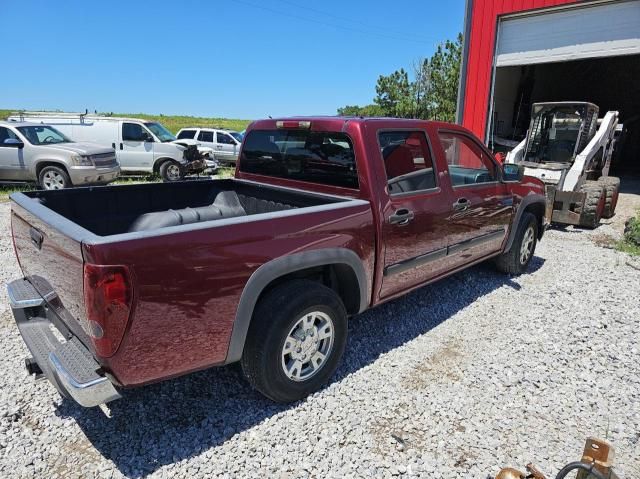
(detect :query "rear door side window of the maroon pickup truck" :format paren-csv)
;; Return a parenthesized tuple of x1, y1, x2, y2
(378, 131, 436, 195)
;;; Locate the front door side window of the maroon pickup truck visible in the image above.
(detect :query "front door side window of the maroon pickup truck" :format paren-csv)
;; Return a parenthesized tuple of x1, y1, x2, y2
(438, 131, 496, 186)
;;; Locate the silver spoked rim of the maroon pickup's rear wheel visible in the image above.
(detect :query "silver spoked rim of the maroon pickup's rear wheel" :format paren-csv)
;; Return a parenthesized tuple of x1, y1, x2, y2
(281, 311, 335, 382)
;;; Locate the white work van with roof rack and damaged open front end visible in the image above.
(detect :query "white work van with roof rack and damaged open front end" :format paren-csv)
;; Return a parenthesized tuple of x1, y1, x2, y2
(8, 112, 217, 181)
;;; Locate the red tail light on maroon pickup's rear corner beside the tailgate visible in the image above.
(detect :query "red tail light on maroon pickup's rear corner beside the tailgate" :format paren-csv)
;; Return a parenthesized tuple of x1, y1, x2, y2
(84, 264, 133, 357)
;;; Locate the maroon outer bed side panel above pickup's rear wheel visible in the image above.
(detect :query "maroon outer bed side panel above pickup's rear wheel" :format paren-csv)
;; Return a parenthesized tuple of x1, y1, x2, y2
(86, 204, 374, 386)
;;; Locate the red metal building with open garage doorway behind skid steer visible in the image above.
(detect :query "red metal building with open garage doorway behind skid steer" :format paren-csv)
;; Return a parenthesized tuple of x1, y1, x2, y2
(458, 0, 640, 172)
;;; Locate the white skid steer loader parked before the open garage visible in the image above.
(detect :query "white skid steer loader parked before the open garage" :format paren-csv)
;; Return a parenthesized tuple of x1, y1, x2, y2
(505, 102, 620, 228)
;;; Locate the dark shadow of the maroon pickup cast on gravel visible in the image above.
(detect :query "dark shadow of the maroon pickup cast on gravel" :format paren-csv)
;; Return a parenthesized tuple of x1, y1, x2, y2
(56, 257, 544, 478)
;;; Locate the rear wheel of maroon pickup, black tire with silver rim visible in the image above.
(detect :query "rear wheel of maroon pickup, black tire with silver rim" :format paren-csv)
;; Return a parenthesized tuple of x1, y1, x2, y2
(240, 280, 347, 403)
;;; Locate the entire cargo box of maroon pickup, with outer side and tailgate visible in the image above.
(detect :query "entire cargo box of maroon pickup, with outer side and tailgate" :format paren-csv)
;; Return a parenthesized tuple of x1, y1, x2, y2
(11, 179, 374, 386)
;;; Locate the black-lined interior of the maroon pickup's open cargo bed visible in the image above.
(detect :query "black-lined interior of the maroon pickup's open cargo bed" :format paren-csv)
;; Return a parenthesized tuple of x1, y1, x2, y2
(24, 179, 345, 237)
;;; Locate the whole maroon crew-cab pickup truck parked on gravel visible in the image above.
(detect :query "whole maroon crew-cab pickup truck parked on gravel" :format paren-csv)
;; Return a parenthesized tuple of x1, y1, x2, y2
(8, 117, 546, 406)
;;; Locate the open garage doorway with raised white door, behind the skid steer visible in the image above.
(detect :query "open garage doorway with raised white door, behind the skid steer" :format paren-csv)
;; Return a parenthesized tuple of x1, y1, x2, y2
(487, 0, 640, 174)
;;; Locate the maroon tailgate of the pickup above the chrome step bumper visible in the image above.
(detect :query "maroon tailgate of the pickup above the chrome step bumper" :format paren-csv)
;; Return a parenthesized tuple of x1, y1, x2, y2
(11, 201, 91, 347)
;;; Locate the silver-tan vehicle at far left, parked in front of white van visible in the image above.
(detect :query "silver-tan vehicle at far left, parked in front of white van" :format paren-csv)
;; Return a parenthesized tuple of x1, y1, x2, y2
(0, 121, 120, 190)
